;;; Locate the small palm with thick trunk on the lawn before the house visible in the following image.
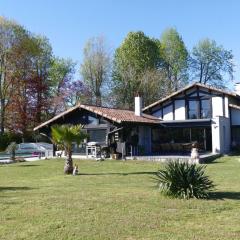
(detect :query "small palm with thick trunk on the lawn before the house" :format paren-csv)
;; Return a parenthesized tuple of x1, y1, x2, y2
(51, 125, 87, 174)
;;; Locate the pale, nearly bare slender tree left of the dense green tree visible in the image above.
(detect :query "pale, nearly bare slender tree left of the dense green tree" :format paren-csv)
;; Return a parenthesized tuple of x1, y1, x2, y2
(80, 37, 111, 106)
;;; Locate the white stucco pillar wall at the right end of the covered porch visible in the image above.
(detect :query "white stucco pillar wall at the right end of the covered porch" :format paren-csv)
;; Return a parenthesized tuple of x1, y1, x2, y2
(212, 116, 231, 154)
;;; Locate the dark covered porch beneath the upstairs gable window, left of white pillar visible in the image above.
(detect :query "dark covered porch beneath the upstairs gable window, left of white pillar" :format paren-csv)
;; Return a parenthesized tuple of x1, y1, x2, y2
(152, 119, 212, 155)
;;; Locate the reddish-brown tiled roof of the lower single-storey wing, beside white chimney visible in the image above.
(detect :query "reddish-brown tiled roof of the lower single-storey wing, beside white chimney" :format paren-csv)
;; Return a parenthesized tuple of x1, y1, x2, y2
(34, 104, 161, 131)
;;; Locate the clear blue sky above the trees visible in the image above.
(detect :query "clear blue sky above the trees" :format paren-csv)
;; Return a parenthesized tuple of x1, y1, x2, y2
(0, 0, 240, 86)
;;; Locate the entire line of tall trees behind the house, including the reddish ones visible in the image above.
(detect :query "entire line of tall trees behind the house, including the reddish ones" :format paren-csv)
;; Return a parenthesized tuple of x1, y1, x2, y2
(0, 17, 234, 145)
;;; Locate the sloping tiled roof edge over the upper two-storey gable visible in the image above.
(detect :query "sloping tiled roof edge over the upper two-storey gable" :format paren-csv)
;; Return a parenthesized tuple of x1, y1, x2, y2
(143, 82, 240, 111)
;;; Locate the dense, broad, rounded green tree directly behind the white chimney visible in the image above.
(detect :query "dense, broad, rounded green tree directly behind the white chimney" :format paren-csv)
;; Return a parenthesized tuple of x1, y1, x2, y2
(112, 32, 161, 109)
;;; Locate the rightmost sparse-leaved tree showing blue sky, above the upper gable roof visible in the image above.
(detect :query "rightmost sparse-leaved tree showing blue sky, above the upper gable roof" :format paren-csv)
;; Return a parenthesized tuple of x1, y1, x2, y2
(191, 39, 234, 88)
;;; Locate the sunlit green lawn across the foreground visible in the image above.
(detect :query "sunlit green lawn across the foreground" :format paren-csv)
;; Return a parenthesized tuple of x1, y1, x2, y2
(0, 157, 240, 240)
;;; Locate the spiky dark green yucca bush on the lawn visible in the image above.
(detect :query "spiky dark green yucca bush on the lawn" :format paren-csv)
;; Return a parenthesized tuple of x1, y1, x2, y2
(155, 161, 214, 199)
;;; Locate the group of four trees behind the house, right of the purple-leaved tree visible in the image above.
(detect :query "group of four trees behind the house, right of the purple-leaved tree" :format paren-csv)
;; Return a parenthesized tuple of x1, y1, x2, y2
(80, 28, 234, 109)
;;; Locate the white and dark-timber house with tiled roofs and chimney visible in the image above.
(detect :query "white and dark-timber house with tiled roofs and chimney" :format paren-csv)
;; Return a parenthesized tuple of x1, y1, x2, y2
(34, 83, 240, 155)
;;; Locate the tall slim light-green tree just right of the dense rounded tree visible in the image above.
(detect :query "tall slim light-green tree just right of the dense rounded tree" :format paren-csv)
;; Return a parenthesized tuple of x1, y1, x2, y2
(160, 28, 188, 92)
